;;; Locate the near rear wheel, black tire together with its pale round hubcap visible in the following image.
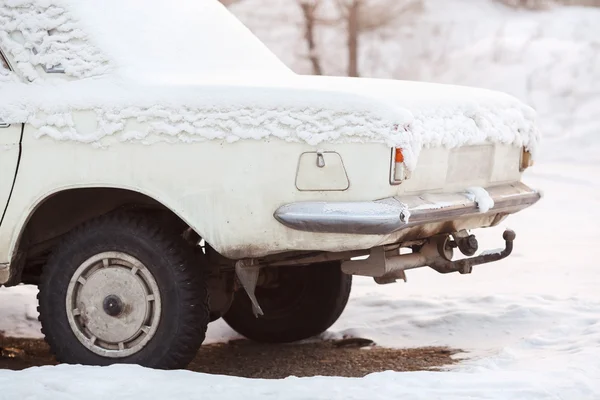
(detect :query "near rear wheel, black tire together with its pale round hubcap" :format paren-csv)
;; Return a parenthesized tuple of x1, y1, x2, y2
(38, 214, 208, 368)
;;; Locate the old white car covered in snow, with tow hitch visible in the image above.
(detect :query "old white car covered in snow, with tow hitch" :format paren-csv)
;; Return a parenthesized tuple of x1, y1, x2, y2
(0, 0, 540, 368)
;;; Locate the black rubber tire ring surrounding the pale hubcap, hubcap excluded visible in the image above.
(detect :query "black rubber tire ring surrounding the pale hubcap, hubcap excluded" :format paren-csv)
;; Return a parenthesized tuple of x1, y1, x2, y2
(38, 214, 209, 369)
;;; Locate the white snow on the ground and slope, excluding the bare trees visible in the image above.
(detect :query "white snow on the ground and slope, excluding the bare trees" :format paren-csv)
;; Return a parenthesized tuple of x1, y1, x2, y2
(0, 0, 600, 400)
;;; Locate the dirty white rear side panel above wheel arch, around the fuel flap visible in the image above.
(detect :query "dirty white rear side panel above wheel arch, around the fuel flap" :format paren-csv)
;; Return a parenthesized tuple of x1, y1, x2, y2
(0, 122, 518, 263)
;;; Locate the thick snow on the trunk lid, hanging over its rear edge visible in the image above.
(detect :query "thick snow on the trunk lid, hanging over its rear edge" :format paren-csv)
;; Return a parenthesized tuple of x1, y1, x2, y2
(302, 77, 540, 170)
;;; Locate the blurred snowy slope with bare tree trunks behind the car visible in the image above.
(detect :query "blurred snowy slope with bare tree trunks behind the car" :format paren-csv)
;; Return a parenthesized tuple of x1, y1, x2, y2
(223, 0, 600, 161)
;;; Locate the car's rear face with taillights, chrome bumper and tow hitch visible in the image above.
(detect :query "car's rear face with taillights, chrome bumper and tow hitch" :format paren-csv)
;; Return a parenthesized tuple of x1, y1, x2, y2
(275, 142, 541, 283)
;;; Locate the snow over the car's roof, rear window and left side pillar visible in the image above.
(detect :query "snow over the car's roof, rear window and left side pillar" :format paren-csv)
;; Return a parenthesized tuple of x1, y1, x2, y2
(0, 0, 289, 81)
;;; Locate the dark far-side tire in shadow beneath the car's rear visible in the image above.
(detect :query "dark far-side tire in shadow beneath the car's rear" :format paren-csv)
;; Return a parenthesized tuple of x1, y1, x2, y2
(223, 262, 352, 343)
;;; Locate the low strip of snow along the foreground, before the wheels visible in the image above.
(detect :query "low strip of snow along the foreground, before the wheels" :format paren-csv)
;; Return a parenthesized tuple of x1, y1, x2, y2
(0, 365, 599, 400)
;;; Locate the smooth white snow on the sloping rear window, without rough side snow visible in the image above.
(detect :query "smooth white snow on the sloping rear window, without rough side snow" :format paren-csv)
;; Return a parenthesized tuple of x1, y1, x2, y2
(69, 0, 291, 82)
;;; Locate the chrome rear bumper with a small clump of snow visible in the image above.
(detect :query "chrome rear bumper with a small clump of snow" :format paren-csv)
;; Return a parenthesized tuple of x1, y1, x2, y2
(274, 182, 541, 235)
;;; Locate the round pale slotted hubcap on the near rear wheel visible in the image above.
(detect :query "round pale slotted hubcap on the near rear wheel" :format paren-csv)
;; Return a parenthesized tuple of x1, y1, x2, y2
(66, 252, 161, 358)
